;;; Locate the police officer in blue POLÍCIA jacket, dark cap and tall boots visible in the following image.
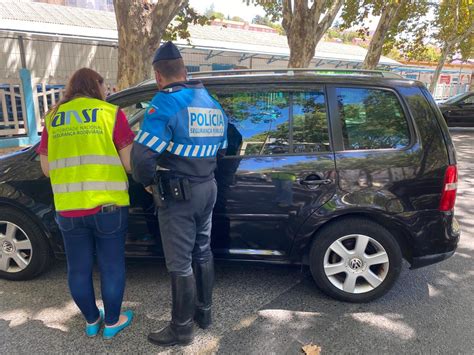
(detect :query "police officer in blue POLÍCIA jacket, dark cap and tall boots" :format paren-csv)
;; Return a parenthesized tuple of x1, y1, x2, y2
(132, 42, 227, 346)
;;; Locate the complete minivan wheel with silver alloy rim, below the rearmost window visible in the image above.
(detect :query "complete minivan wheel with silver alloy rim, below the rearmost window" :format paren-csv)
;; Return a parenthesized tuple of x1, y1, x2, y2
(310, 218, 402, 302)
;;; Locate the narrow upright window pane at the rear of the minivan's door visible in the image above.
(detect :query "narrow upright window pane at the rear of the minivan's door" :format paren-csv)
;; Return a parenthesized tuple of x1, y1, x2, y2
(292, 89, 330, 153)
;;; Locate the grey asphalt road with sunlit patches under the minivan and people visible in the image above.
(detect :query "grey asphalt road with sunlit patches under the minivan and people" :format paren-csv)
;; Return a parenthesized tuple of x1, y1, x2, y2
(0, 131, 474, 354)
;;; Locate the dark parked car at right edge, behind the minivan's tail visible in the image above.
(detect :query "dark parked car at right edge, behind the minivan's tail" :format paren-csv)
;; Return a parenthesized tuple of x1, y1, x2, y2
(438, 91, 474, 127)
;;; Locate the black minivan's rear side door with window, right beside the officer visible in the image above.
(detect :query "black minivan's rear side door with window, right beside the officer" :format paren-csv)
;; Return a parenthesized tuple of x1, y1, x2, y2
(208, 84, 335, 260)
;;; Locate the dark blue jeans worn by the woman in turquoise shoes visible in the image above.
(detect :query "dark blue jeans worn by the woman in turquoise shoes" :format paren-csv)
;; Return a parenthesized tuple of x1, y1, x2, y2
(56, 207, 128, 325)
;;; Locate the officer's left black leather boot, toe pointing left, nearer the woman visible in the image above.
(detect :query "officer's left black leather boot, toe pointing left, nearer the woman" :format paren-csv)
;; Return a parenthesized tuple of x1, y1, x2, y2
(148, 275, 196, 346)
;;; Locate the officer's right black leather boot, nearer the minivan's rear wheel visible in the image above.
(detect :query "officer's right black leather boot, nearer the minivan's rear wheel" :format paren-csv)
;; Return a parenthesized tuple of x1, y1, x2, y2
(193, 257, 214, 329)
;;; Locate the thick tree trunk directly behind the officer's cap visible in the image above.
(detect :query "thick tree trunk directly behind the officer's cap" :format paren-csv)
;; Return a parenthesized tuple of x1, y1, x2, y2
(114, 0, 186, 90)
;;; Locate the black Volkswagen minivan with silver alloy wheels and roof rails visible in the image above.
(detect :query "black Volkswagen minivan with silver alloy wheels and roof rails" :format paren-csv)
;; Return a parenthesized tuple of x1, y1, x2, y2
(0, 69, 460, 302)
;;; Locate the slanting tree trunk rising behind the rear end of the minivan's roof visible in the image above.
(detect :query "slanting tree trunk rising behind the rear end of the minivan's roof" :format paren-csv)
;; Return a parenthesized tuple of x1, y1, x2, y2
(362, 1, 404, 70)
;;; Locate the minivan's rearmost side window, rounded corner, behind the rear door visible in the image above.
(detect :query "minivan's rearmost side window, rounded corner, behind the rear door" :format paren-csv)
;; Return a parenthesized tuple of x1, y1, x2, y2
(336, 88, 410, 150)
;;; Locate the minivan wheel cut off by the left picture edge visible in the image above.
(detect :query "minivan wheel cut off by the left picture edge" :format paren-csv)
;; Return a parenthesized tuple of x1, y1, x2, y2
(0, 207, 52, 280)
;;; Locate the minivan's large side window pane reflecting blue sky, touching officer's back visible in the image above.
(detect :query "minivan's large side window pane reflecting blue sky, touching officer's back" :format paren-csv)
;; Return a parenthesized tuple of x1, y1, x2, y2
(214, 92, 290, 156)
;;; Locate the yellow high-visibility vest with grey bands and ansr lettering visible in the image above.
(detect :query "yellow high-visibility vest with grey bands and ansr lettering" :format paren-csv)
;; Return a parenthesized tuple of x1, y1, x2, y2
(45, 97, 130, 211)
